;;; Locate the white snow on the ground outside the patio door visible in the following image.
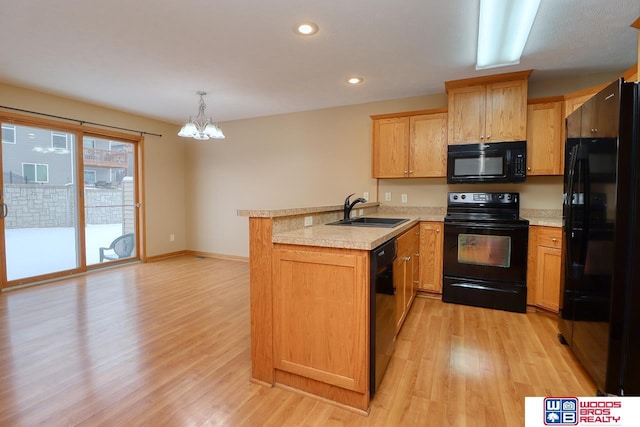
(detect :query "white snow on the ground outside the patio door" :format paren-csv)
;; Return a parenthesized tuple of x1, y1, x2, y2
(5, 224, 127, 280)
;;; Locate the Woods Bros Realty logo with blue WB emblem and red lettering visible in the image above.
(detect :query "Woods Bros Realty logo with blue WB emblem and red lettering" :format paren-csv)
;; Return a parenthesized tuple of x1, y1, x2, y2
(543, 397, 622, 426)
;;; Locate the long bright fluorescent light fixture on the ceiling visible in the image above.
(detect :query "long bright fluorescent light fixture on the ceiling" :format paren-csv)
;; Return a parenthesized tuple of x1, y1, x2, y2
(476, 0, 540, 70)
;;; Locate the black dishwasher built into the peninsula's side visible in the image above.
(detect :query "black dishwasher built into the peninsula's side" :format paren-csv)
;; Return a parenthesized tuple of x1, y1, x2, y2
(369, 237, 396, 397)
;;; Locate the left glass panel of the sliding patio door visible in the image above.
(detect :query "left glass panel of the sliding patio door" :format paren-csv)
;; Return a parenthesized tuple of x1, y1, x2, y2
(2, 123, 80, 281)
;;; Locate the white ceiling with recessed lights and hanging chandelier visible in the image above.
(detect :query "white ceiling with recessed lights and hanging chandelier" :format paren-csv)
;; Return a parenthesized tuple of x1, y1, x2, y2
(0, 0, 640, 123)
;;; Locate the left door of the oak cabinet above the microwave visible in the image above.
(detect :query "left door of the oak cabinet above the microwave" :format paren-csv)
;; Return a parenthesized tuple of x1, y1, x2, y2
(447, 85, 487, 144)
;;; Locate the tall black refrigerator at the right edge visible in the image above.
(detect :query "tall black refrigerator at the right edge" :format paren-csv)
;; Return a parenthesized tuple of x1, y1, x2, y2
(558, 79, 640, 396)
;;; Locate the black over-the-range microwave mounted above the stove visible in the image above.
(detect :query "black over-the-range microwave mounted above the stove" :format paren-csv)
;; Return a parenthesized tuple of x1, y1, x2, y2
(447, 141, 527, 184)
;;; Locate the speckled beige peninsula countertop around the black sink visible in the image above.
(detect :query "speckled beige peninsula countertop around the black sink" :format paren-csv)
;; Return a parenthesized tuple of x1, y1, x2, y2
(272, 214, 421, 251)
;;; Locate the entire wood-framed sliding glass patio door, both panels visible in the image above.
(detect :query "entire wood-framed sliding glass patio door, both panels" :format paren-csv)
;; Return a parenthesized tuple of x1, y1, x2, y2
(0, 118, 140, 288)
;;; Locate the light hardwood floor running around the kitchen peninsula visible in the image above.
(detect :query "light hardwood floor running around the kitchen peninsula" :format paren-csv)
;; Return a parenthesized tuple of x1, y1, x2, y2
(0, 256, 595, 427)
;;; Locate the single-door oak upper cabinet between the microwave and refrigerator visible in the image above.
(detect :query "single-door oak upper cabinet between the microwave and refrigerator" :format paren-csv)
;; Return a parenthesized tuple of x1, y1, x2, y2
(526, 101, 564, 175)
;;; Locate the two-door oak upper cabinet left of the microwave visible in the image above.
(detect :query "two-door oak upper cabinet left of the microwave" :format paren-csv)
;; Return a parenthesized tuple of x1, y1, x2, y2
(371, 109, 447, 178)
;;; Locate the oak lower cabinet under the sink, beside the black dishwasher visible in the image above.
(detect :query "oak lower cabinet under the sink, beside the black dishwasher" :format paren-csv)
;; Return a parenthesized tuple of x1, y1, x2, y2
(393, 225, 420, 334)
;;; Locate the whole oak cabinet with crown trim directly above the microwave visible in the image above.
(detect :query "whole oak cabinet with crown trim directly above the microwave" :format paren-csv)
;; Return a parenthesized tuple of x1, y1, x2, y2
(445, 70, 531, 144)
